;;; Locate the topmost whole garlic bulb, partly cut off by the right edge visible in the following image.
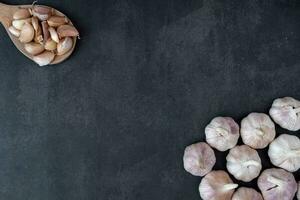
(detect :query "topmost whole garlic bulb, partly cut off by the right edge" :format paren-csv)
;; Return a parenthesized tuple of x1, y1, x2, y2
(270, 97, 300, 131)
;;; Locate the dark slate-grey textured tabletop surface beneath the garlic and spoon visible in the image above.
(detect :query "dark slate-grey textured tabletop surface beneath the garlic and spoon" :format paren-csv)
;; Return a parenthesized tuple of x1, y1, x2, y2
(0, 0, 300, 200)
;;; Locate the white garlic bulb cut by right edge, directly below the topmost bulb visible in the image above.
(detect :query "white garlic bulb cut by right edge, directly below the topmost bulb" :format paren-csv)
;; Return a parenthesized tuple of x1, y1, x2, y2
(268, 134, 300, 172)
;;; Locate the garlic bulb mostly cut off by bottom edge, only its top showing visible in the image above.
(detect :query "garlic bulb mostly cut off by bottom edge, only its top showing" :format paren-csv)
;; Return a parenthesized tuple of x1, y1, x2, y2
(232, 187, 264, 200)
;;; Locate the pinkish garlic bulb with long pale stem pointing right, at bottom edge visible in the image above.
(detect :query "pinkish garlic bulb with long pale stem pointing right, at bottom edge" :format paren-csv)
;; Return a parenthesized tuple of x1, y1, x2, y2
(199, 170, 238, 200)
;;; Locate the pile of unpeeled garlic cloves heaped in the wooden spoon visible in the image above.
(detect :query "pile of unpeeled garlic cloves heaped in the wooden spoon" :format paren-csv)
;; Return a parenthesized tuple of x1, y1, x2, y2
(8, 5, 79, 66)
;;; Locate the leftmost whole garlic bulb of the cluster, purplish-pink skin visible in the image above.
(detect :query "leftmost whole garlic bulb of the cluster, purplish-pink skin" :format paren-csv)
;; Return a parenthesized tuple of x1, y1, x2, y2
(183, 142, 216, 176)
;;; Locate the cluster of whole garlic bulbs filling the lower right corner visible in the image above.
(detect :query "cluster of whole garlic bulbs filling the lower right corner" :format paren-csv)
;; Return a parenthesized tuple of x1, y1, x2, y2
(183, 97, 300, 200)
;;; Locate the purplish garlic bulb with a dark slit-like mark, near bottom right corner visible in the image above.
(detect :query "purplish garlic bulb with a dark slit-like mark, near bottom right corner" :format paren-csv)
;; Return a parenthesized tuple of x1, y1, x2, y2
(257, 168, 297, 200)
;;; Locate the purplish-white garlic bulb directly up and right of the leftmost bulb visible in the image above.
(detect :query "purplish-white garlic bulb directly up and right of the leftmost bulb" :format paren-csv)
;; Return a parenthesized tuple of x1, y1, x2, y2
(205, 117, 240, 151)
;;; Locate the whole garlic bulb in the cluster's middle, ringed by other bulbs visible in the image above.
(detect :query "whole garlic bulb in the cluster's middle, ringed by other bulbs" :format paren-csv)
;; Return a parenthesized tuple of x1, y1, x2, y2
(226, 145, 262, 182)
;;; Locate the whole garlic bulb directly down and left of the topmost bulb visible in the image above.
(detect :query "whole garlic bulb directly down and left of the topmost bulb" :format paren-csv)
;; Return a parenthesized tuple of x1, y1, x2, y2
(241, 113, 276, 149)
